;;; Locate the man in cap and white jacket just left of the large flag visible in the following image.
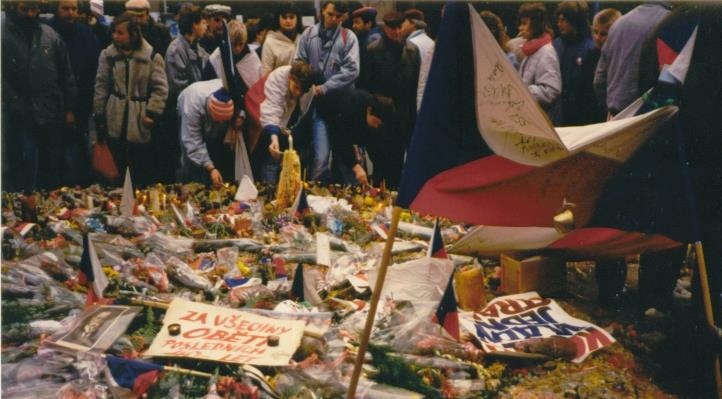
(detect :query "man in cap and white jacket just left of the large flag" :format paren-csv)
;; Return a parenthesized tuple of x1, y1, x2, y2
(401, 8, 436, 112)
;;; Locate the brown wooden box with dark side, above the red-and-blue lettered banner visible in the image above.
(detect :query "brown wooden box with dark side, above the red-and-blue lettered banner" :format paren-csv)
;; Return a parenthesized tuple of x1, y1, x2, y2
(501, 254, 566, 296)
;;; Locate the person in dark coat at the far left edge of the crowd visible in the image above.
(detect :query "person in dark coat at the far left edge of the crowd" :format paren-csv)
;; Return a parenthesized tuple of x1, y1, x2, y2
(2, 1, 77, 193)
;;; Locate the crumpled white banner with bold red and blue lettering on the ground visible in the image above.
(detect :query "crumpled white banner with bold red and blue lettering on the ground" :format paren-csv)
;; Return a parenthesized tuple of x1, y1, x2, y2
(459, 292, 614, 363)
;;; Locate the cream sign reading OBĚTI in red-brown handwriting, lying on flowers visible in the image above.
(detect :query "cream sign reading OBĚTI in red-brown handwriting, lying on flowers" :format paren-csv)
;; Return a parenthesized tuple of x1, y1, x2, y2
(143, 299, 306, 366)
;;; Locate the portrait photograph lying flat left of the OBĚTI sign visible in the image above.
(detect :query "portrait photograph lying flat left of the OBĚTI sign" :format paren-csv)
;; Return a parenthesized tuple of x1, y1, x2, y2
(46, 305, 142, 353)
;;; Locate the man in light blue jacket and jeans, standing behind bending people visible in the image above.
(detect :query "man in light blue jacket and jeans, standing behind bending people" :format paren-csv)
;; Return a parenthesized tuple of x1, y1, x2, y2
(295, 1, 360, 184)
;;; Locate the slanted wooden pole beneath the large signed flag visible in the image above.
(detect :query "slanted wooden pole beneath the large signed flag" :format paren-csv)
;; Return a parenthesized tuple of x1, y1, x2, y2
(346, 206, 401, 399)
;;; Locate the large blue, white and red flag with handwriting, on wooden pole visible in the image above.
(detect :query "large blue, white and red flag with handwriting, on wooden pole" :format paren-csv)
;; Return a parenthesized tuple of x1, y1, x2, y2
(397, 3, 688, 256)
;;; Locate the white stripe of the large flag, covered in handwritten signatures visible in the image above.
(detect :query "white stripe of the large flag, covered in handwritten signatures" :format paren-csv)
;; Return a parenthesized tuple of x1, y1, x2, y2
(470, 4, 677, 166)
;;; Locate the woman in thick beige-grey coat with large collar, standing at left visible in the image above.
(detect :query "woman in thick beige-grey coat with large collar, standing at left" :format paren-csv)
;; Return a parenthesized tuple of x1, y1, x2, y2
(93, 14, 168, 185)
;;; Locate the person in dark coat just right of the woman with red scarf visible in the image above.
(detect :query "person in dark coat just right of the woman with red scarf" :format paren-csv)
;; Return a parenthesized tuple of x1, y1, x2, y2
(552, 0, 594, 126)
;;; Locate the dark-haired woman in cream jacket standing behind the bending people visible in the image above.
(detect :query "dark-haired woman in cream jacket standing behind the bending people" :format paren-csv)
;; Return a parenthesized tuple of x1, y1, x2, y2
(261, 3, 303, 75)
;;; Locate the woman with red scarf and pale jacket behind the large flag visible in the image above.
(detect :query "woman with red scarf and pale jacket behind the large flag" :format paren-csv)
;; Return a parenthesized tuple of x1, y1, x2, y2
(519, 3, 562, 125)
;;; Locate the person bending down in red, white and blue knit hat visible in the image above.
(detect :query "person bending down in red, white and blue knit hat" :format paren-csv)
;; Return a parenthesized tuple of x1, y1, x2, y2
(177, 79, 235, 187)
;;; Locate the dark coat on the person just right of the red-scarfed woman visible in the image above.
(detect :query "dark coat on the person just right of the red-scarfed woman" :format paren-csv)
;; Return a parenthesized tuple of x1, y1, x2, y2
(553, 36, 595, 126)
